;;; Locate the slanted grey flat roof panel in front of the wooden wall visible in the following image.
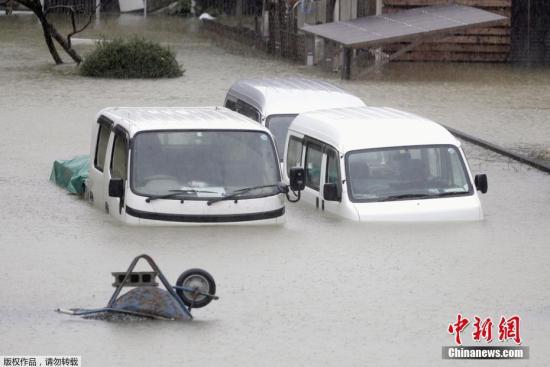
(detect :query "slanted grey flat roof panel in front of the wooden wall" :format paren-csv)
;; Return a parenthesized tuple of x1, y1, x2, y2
(302, 4, 507, 48)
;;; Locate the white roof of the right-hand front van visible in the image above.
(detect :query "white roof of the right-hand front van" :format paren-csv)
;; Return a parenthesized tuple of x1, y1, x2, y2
(289, 107, 460, 153)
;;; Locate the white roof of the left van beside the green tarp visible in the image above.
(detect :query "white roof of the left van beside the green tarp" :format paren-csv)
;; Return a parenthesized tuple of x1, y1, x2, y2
(98, 107, 267, 136)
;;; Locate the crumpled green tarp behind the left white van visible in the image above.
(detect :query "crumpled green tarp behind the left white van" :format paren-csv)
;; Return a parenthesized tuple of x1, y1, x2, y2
(50, 155, 90, 194)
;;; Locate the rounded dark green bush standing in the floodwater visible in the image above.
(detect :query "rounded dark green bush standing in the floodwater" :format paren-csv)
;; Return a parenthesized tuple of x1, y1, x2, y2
(79, 38, 184, 79)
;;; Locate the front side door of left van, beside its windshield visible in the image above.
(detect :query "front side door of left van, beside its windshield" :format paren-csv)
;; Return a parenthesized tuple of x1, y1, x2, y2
(105, 129, 129, 219)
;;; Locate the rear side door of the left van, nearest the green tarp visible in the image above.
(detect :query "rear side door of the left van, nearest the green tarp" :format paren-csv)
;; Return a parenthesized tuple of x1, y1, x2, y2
(87, 116, 112, 210)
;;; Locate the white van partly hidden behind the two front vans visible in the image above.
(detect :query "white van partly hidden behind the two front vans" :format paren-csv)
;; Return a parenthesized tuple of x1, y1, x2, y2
(224, 78, 365, 160)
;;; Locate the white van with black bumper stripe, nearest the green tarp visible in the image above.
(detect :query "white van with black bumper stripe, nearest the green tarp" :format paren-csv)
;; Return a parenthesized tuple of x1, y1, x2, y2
(86, 107, 306, 224)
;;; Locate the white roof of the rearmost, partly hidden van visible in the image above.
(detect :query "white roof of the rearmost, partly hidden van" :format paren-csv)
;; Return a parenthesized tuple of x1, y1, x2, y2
(228, 78, 365, 117)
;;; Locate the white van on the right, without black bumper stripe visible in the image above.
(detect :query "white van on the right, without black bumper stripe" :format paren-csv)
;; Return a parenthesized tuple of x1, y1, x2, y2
(284, 107, 487, 221)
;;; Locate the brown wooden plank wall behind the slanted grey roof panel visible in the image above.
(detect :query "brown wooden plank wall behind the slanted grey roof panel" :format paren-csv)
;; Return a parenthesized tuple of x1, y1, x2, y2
(383, 0, 512, 62)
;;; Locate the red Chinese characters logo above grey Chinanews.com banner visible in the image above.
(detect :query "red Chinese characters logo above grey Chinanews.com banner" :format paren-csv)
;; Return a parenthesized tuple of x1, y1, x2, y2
(442, 313, 529, 359)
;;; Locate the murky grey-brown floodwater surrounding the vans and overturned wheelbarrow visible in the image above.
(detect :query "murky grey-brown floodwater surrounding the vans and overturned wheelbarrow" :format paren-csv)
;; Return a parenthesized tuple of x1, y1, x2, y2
(0, 15, 550, 366)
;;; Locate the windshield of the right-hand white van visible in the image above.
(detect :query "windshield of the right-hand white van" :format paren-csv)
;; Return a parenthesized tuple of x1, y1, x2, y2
(346, 145, 473, 202)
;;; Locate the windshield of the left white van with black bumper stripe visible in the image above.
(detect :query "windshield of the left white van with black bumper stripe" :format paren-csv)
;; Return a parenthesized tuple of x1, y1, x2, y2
(130, 130, 281, 200)
